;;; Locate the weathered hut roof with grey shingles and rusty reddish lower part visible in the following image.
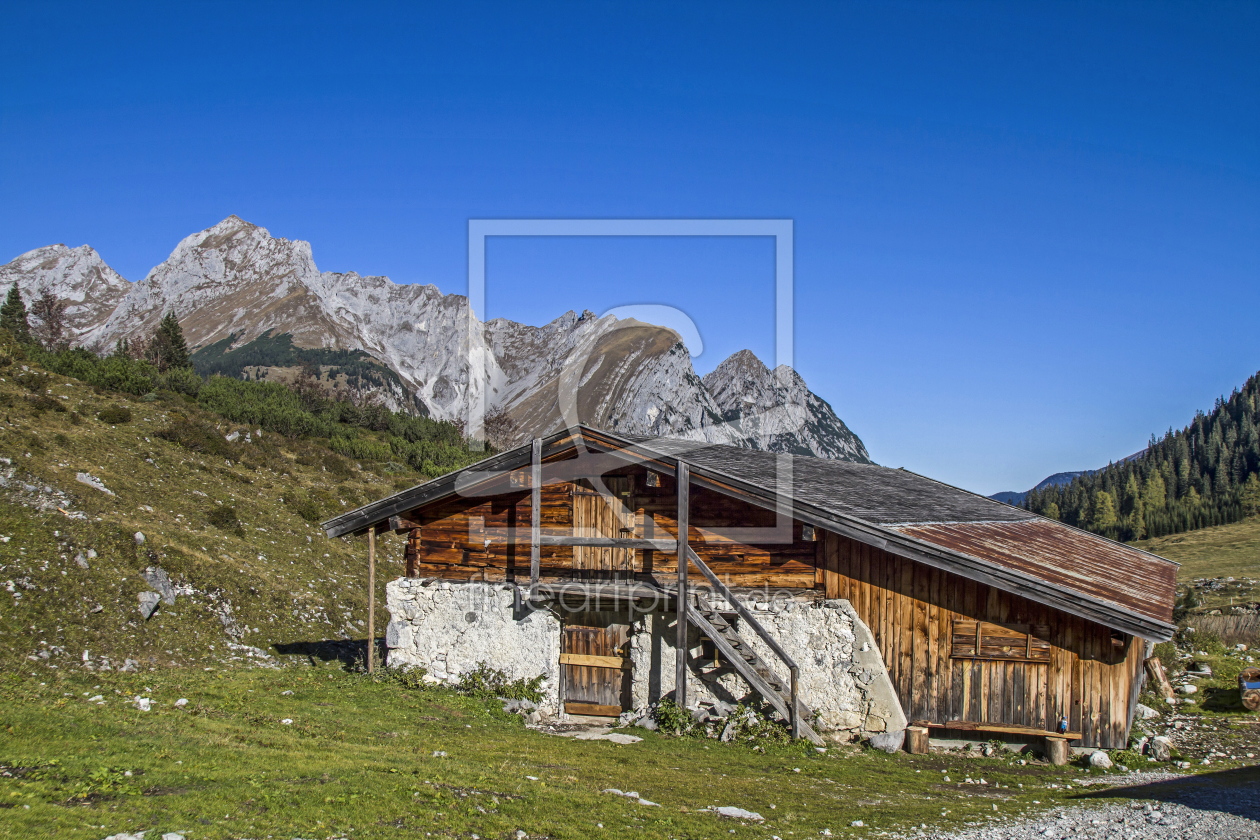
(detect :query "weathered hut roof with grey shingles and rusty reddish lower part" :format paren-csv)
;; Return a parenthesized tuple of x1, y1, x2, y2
(323, 427, 1177, 641)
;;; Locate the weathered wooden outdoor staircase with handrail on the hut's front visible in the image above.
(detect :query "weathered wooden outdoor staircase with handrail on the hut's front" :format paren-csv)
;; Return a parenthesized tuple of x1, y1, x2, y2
(679, 548, 823, 746)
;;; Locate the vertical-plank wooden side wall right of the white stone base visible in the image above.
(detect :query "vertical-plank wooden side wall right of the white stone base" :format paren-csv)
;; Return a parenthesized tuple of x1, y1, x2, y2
(819, 531, 1144, 748)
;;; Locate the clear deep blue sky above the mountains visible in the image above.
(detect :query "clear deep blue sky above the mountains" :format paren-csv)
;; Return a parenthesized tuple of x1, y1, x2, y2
(0, 3, 1260, 494)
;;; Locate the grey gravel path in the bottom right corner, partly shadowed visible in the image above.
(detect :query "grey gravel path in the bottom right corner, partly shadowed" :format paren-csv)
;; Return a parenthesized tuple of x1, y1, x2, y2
(902, 771, 1260, 840)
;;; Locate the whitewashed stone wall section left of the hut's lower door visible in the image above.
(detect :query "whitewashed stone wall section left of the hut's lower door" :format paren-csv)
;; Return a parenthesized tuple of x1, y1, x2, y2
(386, 578, 559, 713)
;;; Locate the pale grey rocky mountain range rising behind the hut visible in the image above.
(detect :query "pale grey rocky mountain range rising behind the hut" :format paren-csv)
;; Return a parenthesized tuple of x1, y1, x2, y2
(0, 215, 867, 460)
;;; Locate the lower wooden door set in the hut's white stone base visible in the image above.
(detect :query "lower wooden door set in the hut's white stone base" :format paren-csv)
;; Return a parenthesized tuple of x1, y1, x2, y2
(559, 612, 630, 718)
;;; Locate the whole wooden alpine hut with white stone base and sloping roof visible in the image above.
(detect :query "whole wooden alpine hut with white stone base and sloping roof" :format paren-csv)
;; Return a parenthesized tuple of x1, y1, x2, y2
(324, 427, 1177, 748)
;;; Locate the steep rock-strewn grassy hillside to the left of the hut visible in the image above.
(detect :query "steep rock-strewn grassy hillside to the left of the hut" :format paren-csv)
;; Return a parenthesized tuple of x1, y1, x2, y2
(0, 363, 422, 674)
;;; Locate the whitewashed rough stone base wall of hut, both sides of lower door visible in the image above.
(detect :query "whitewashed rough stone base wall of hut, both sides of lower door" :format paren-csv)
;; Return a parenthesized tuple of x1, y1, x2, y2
(386, 578, 906, 739)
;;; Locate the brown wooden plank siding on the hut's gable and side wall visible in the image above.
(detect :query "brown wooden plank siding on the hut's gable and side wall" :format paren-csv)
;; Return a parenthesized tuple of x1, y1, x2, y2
(407, 456, 1143, 748)
